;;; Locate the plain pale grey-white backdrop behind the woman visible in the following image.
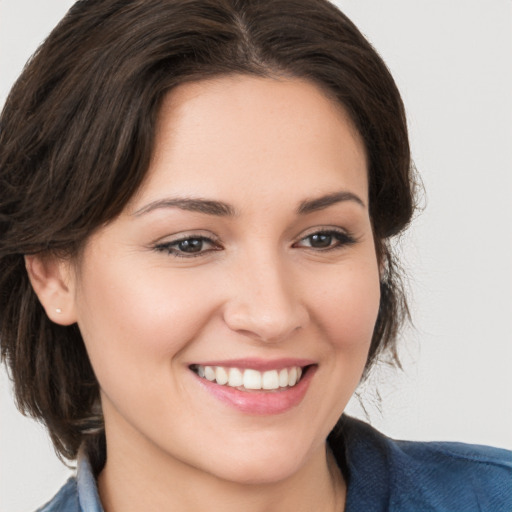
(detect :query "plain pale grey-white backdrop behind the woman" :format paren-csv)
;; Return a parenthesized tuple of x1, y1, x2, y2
(0, 0, 512, 512)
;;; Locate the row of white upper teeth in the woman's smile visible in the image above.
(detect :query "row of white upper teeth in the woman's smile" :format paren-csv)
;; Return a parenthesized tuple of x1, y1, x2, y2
(195, 365, 302, 390)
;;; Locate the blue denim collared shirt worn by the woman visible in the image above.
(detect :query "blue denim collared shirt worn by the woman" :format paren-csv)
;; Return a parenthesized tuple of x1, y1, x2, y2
(38, 417, 512, 512)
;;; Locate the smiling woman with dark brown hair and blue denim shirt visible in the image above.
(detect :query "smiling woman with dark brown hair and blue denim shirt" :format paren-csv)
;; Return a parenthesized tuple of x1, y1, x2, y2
(0, 0, 512, 511)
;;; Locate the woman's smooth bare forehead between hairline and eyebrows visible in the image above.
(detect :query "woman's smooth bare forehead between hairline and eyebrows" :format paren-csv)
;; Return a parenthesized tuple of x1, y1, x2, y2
(128, 75, 368, 211)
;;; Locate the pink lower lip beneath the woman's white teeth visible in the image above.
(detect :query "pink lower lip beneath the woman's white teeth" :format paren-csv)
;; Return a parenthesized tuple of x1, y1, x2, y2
(194, 366, 317, 415)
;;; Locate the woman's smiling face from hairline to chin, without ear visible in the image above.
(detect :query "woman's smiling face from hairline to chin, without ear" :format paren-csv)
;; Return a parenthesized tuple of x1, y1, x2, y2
(67, 76, 379, 483)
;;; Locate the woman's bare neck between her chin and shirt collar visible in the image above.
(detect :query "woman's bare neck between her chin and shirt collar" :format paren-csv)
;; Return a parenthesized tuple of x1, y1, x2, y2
(98, 437, 346, 512)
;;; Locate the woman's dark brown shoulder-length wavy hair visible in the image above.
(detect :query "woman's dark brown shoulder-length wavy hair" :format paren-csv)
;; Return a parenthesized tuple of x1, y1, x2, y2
(0, 0, 414, 459)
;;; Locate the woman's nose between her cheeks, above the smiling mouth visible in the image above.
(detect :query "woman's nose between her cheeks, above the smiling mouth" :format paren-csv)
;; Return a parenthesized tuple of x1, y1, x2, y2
(224, 249, 309, 343)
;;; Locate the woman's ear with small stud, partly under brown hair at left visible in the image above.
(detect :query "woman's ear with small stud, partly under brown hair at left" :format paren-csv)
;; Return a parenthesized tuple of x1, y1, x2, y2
(25, 253, 77, 325)
